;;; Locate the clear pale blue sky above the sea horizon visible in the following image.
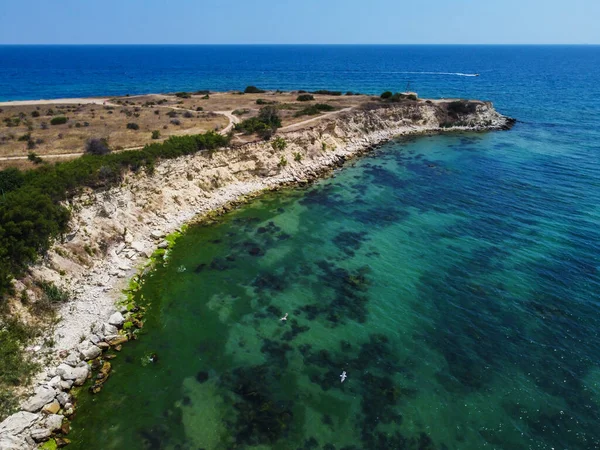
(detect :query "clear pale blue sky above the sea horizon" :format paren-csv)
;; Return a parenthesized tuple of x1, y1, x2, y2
(0, 0, 600, 44)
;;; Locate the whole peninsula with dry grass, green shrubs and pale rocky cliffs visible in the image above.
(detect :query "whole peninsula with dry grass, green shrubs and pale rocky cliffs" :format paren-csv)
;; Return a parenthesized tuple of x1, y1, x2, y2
(0, 86, 514, 449)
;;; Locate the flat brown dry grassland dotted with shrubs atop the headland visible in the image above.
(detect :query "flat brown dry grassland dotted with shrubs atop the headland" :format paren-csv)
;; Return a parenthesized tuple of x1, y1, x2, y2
(0, 92, 370, 169)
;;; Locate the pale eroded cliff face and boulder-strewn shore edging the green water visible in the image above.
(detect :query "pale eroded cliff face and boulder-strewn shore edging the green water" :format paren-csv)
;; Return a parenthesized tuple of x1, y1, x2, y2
(0, 97, 514, 450)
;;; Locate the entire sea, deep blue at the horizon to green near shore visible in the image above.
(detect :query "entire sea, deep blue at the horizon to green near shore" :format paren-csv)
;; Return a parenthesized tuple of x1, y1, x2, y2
(5, 46, 600, 450)
